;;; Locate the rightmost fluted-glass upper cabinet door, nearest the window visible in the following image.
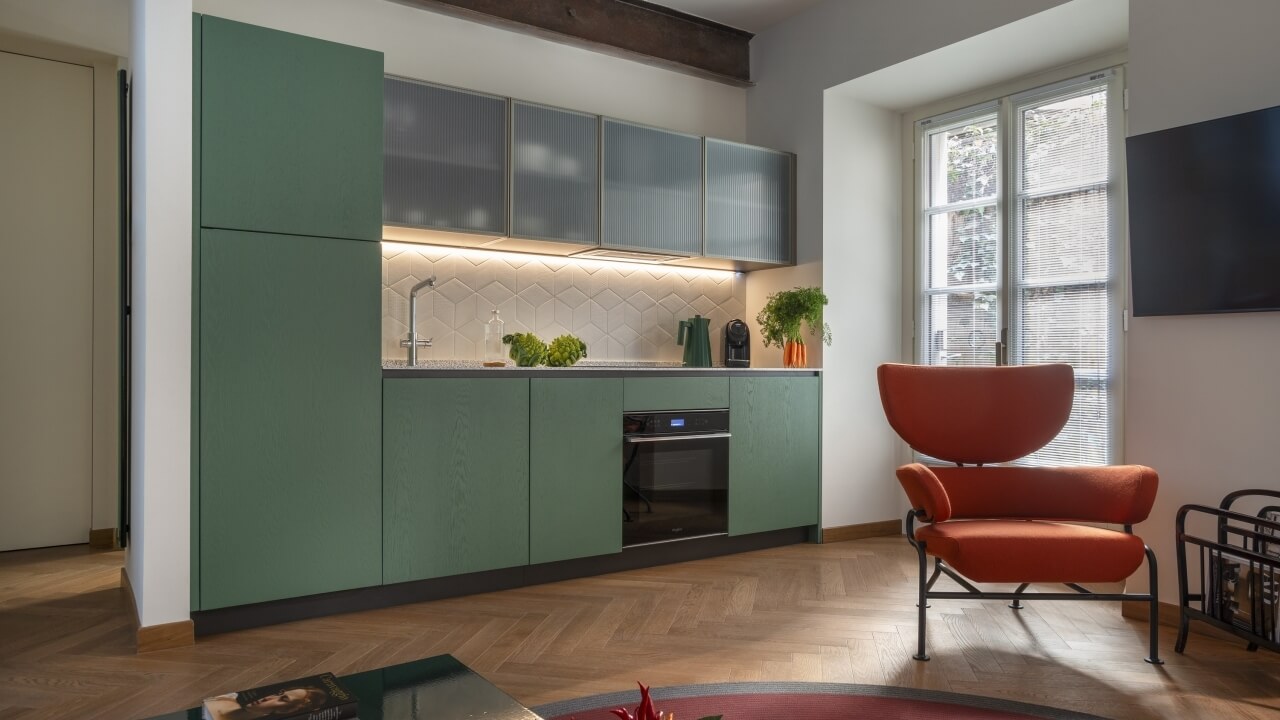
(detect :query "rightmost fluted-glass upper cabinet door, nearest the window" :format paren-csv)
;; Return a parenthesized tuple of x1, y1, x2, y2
(707, 138, 795, 264)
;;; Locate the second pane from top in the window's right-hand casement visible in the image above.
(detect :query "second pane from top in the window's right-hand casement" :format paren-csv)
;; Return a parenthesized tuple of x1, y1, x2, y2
(1020, 187, 1111, 282)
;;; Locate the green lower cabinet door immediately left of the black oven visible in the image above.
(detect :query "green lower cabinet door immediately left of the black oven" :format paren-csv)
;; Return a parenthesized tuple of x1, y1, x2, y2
(529, 378, 622, 562)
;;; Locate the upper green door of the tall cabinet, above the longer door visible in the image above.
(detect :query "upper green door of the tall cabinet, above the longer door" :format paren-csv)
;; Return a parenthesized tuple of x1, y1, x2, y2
(200, 17, 383, 241)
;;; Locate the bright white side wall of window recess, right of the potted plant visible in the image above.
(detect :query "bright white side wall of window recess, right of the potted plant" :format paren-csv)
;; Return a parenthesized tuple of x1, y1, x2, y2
(820, 90, 905, 520)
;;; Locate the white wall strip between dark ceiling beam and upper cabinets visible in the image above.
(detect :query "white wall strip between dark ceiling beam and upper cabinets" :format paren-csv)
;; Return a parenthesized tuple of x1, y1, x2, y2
(195, 0, 746, 141)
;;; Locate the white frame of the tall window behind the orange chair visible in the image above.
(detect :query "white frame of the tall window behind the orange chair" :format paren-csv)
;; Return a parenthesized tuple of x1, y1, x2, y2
(910, 65, 1128, 464)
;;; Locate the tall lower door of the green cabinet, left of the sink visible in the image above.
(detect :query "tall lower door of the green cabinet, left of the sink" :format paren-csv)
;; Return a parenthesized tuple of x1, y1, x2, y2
(196, 229, 383, 610)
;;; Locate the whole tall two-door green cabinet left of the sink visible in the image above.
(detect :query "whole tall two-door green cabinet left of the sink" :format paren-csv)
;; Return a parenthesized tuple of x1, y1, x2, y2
(192, 15, 383, 610)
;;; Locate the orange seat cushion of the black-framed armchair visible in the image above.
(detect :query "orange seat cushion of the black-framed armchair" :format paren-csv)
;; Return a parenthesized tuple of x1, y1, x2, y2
(915, 520, 1144, 583)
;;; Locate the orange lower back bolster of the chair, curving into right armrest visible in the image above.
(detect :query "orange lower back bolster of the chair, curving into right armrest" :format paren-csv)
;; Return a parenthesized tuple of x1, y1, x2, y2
(932, 465, 1160, 525)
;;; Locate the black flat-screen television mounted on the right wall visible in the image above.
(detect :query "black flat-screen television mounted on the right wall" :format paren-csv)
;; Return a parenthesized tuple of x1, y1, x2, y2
(1125, 106, 1280, 316)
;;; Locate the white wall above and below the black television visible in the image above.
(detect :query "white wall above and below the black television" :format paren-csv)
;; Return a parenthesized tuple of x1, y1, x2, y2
(1125, 0, 1280, 602)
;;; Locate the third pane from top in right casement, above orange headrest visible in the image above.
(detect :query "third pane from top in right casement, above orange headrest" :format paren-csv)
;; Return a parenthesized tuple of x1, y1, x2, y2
(1016, 283, 1110, 374)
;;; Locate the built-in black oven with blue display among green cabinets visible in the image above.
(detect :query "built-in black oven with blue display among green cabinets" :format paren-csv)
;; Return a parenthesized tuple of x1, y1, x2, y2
(622, 410, 730, 547)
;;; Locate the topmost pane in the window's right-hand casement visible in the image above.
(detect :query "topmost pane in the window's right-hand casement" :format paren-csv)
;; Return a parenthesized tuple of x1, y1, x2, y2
(1021, 90, 1110, 192)
